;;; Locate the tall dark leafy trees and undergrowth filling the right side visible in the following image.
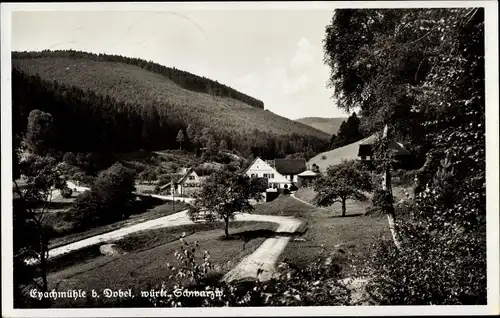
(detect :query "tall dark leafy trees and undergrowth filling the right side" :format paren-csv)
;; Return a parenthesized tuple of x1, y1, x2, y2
(324, 8, 486, 305)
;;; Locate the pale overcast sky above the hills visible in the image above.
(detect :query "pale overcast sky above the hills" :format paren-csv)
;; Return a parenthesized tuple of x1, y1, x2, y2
(12, 10, 346, 119)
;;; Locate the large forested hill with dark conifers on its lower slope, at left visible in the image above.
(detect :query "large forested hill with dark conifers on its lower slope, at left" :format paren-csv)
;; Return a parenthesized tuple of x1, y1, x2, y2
(12, 51, 329, 158)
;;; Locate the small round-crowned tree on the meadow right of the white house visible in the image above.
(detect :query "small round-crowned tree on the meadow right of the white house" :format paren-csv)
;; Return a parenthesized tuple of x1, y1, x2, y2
(314, 160, 372, 216)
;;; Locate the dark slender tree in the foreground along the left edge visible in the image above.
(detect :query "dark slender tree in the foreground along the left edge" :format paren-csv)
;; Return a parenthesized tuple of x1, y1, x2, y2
(13, 154, 67, 302)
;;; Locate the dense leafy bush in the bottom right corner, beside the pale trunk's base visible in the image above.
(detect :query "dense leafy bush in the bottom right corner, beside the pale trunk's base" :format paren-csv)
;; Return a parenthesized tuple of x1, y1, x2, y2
(367, 222, 486, 305)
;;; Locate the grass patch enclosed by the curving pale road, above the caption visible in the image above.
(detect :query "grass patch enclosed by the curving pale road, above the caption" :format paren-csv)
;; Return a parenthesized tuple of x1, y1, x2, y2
(48, 221, 277, 307)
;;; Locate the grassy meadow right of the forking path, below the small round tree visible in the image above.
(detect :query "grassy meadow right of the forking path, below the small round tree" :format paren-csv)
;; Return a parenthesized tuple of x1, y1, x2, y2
(254, 190, 390, 276)
